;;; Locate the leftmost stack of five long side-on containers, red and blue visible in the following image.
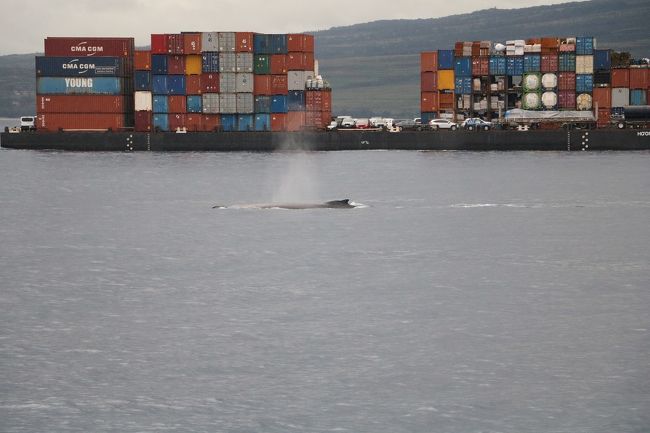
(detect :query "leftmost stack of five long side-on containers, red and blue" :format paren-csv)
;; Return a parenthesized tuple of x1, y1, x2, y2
(36, 38, 134, 131)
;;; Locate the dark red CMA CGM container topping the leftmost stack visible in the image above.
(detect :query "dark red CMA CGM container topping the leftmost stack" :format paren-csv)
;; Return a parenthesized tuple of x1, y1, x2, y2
(45, 37, 135, 57)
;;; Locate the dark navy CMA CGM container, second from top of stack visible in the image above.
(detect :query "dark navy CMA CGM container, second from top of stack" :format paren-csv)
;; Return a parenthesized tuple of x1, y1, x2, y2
(36, 56, 131, 77)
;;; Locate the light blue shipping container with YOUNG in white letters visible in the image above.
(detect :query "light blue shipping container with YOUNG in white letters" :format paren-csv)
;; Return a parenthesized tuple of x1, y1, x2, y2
(36, 77, 127, 95)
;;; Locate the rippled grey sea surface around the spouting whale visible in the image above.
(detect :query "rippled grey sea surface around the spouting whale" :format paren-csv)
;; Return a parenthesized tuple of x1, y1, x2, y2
(0, 149, 650, 433)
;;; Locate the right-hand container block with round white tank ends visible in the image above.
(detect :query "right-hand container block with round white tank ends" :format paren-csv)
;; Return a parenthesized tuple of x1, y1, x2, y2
(420, 36, 650, 125)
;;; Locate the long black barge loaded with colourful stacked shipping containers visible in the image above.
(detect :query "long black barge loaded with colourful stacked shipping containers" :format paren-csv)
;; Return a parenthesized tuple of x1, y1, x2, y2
(1, 32, 650, 151)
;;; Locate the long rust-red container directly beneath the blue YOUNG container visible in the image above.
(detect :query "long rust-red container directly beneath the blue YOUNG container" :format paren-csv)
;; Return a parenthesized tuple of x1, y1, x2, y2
(36, 95, 125, 113)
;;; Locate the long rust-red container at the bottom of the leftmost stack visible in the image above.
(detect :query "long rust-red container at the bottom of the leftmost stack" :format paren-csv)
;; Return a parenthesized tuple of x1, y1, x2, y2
(36, 113, 126, 131)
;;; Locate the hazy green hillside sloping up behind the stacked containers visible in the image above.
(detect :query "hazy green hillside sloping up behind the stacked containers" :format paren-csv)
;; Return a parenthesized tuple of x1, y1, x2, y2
(0, 0, 650, 117)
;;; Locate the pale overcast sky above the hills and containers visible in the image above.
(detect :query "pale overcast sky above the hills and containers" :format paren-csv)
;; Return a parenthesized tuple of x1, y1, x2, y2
(0, 0, 566, 55)
